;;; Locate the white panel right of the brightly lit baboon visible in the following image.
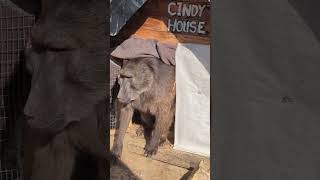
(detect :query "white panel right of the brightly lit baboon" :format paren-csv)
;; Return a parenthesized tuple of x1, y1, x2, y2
(174, 44, 210, 156)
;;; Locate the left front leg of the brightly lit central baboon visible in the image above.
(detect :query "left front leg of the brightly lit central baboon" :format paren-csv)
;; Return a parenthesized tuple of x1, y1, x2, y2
(111, 104, 133, 157)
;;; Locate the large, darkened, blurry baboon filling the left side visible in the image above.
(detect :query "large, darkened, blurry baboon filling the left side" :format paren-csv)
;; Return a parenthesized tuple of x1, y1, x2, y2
(14, 0, 109, 180)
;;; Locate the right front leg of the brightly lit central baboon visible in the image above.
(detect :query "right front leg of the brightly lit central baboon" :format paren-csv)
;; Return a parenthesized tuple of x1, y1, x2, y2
(145, 109, 171, 157)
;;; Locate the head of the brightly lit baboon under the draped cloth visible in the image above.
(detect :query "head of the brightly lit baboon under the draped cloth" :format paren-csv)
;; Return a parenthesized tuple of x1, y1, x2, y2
(118, 59, 154, 103)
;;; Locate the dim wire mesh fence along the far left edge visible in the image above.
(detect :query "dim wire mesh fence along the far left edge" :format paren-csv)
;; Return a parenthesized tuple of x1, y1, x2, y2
(0, 0, 34, 180)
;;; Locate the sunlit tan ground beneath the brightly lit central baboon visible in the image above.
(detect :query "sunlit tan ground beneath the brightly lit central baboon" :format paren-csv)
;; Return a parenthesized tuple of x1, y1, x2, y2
(110, 125, 210, 180)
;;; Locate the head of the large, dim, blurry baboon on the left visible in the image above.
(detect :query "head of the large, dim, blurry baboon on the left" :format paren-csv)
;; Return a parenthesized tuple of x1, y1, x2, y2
(24, 0, 109, 132)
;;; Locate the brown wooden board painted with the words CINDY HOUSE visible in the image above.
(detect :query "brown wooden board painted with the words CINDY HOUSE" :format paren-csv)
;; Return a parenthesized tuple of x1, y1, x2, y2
(111, 0, 211, 47)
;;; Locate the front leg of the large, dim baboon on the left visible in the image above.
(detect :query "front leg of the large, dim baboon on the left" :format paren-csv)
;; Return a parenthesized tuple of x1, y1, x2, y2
(31, 131, 76, 180)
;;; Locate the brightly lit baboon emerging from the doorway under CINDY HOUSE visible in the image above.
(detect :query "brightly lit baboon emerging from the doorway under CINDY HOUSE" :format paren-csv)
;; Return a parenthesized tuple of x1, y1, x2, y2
(111, 58, 175, 158)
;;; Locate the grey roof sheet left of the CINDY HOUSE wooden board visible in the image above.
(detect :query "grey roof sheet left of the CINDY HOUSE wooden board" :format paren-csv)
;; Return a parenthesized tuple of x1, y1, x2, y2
(110, 0, 147, 36)
